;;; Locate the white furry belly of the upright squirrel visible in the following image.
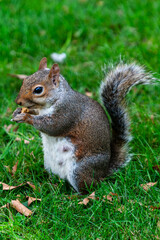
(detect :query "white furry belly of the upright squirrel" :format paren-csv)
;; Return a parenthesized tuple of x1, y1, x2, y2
(41, 133, 76, 189)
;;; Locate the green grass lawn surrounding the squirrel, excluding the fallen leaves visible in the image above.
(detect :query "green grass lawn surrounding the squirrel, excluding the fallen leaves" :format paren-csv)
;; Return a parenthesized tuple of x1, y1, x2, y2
(0, 0, 160, 240)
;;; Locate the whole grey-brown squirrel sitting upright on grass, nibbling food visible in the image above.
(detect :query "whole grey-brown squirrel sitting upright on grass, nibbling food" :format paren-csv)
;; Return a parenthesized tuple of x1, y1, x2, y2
(12, 58, 154, 194)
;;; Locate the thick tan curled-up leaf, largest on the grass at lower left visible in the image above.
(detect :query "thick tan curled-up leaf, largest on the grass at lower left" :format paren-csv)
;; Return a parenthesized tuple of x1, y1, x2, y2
(10, 199, 33, 217)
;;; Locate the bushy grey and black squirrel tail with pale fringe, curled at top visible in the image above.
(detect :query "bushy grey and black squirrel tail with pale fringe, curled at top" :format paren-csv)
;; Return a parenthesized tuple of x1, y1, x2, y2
(101, 64, 155, 173)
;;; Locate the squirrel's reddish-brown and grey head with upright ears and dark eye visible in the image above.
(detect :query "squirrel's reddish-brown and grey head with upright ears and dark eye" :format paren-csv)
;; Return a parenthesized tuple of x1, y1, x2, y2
(16, 58, 69, 109)
